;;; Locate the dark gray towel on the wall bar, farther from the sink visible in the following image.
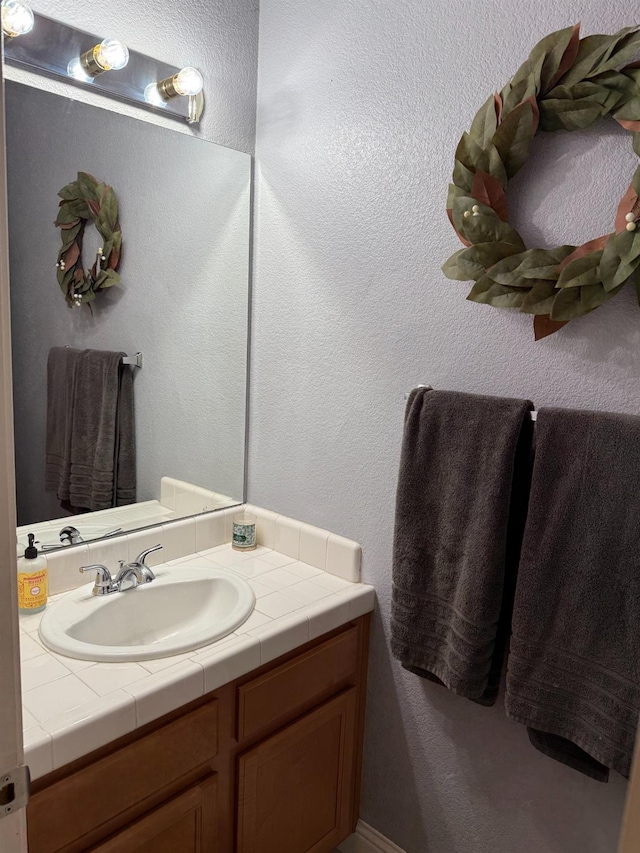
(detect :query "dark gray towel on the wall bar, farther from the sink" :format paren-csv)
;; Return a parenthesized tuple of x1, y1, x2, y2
(506, 409, 640, 780)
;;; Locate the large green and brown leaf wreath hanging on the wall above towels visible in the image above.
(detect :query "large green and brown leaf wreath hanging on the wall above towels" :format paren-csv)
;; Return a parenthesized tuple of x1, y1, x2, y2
(442, 24, 640, 340)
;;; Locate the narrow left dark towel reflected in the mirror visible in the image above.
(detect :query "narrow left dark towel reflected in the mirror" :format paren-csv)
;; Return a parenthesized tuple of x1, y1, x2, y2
(45, 347, 82, 501)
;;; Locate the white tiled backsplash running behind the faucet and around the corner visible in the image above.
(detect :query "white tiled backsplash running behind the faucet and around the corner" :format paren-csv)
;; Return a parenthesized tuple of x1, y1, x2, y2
(47, 502, 362, 595)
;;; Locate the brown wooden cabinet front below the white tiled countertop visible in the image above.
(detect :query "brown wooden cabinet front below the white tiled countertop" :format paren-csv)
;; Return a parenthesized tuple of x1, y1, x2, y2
(27, 616, 369, 853)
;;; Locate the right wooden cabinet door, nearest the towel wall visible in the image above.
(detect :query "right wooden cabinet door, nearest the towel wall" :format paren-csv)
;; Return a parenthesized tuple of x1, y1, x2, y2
(237, 688, 357, 853)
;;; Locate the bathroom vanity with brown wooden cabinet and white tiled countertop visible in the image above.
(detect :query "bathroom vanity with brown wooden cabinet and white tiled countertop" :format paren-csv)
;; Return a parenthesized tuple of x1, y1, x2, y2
(21, 506, 374, 853)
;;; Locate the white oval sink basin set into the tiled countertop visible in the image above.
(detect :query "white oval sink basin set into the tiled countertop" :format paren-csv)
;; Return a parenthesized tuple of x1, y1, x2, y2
(40, 566, 255, 661)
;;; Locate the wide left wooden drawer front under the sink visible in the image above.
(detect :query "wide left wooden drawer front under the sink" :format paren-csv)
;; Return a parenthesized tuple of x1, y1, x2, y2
(27, 702, 218, 853)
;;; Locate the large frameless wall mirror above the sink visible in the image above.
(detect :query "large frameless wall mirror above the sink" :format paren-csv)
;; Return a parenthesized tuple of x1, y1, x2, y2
(6, 82, 251, 548)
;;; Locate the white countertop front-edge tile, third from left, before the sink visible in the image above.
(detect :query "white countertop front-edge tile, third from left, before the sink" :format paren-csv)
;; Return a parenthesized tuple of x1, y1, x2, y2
(124, 661, 204, 727)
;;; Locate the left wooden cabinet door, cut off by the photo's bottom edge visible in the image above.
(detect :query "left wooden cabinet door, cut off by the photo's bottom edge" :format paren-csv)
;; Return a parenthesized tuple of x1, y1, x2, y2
(87, 775, 217, 853)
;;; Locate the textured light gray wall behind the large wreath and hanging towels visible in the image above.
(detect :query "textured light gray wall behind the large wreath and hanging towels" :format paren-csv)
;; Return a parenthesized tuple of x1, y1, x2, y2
(249, 0, 640, 853)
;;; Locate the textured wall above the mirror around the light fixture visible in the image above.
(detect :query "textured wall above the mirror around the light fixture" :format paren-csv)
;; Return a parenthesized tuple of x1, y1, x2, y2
(7, 0, 259, 154)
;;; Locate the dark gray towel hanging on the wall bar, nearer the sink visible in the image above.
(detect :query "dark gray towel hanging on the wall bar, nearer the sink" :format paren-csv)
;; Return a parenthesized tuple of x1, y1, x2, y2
(391, 389, 533, 705)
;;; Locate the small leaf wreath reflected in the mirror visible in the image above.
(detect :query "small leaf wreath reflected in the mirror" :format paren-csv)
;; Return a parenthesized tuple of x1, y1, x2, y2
(54, 172, 122, 309)
